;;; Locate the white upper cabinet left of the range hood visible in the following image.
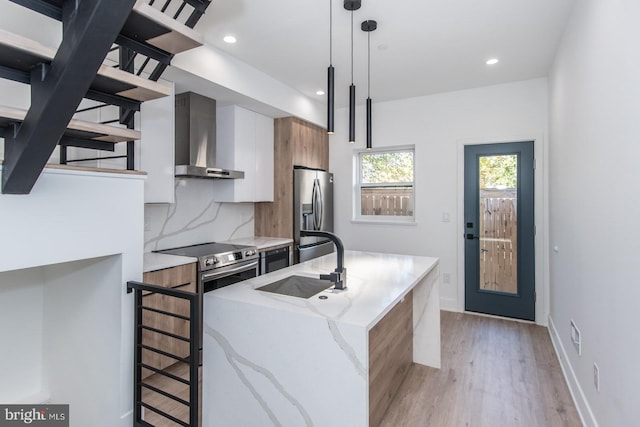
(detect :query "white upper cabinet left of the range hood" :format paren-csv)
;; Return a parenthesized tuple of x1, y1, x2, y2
(140, 82, 175, 203)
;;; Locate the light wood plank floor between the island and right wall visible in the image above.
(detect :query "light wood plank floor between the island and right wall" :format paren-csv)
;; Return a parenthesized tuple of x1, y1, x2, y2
(381, 311, 581, 427)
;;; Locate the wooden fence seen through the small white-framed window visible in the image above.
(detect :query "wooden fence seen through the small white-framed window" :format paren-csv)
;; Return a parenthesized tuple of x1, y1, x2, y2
(360, 187, 413, 216)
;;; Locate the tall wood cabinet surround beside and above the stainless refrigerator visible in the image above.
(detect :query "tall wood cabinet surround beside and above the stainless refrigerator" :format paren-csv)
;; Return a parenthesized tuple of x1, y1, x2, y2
(254, 117, 329, 239)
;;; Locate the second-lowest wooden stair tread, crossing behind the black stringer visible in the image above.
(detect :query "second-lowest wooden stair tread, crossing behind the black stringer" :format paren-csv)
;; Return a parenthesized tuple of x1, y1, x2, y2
(0, 29, 171, 102)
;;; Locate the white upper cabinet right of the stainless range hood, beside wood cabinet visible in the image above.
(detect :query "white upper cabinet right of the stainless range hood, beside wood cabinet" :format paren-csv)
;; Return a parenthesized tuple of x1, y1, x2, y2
(214, 105, 274, 202)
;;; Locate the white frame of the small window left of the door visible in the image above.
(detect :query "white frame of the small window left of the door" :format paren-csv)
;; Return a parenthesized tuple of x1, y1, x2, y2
(352, 145, 416, 225)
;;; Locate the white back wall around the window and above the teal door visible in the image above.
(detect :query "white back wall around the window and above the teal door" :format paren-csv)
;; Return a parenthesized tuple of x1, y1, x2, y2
(330, 79, 548, 310)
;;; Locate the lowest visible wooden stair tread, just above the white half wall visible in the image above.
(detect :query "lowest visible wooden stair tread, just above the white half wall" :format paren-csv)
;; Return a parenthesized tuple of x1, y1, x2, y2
(0, 105, 141, 143)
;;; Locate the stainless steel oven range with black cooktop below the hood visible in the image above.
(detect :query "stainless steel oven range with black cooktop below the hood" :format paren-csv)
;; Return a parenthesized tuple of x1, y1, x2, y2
(156, 243, 259, 361)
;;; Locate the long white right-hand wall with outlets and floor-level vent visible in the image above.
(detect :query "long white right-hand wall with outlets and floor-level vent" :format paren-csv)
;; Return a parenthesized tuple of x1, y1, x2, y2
(549, 0, 640, 426)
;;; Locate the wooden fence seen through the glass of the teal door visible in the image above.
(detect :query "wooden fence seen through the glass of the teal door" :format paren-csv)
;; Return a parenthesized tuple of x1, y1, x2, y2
(480, 189, 518, 293)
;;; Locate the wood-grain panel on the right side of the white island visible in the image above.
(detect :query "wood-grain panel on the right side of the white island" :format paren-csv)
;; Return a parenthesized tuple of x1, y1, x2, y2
(369, 291, 413, 426)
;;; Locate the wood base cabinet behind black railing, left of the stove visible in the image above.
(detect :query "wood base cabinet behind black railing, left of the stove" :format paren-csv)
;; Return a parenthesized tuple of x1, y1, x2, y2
(142, 263, 197, 378)
